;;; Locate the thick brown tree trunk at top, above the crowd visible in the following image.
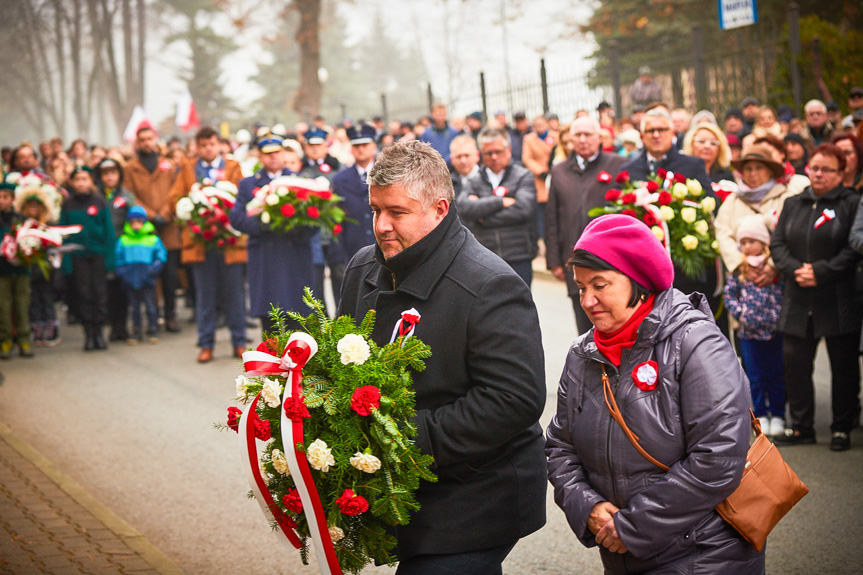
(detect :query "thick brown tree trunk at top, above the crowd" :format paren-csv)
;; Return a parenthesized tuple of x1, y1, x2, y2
(293, 0, 321, 120)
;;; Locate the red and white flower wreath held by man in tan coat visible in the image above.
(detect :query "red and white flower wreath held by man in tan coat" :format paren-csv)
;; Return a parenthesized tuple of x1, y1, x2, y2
(176, 178, 241, 250)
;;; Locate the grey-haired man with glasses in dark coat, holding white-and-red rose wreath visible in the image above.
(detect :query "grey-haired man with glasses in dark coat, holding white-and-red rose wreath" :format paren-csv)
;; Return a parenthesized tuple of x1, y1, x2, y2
(621, 107, 729, 335)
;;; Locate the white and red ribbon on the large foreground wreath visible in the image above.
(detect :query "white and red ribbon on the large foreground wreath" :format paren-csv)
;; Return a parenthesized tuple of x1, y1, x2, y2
(240, 332, 342, 575)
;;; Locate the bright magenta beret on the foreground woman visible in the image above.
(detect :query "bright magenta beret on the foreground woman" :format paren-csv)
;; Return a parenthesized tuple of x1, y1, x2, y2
(573, 214, 674, 292)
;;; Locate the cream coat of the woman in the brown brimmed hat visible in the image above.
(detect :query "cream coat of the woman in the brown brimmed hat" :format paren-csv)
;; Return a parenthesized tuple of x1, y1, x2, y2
(714, 180, 808, 273)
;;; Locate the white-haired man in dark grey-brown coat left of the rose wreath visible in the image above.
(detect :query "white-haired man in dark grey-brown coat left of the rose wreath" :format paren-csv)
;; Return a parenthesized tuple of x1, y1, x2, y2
(545, 116, 626, 333)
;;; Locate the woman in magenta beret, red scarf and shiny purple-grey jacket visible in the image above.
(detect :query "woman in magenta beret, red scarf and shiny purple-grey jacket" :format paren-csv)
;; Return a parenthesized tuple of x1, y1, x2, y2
(546, 215, 764, 574)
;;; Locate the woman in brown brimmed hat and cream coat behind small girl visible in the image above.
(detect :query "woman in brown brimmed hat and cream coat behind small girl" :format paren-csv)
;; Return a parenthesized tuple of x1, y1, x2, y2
(715, 144, 794, 286)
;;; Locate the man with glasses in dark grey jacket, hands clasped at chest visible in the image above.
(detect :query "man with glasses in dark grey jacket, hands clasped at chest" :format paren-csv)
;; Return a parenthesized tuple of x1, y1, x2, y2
(455, 128, 538, 286)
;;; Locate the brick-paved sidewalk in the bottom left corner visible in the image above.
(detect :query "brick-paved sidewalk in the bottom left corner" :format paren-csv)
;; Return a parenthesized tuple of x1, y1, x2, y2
(0, 423, 184, 575)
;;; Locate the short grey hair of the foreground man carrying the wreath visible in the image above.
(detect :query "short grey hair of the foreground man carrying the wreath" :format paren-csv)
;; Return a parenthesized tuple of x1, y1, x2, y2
(368, 140, 455, 210)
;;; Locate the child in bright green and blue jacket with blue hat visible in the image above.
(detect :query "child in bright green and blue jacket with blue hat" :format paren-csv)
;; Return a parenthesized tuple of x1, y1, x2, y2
(115, 206, 168, 345)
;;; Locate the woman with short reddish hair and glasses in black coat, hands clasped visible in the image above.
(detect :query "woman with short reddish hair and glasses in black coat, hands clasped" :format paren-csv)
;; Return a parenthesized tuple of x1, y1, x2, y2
(770, 144, 863, 451)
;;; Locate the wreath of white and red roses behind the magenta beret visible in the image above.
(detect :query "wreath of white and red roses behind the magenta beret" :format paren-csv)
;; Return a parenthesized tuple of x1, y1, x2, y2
(588, 168, 719, 278)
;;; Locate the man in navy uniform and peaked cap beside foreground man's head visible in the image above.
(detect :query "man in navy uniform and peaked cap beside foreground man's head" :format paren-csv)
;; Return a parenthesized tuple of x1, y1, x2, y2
(333, 124, 378, 270)
